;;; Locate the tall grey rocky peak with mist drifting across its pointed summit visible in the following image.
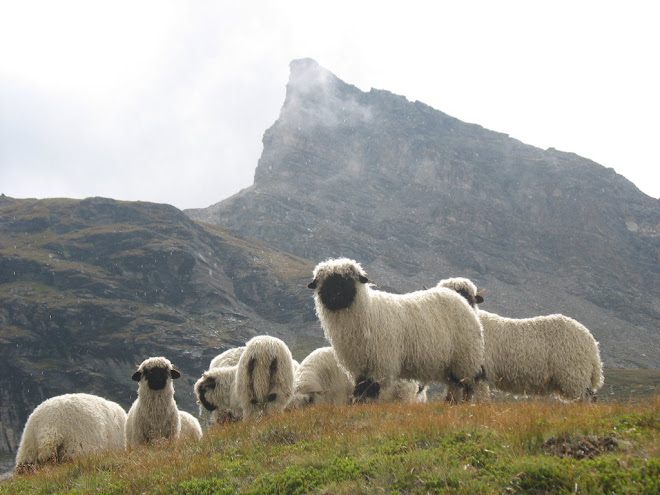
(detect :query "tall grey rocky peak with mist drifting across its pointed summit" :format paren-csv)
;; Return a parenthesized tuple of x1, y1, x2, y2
(187, 59, 660, 368)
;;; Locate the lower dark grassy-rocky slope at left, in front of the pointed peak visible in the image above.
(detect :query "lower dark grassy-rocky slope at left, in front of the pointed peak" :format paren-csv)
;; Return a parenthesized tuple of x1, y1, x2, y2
(0, 197, 322, 452)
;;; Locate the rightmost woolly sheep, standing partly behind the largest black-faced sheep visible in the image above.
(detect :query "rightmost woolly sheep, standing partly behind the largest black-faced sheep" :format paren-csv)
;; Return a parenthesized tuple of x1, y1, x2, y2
(439, 278, 604, 401)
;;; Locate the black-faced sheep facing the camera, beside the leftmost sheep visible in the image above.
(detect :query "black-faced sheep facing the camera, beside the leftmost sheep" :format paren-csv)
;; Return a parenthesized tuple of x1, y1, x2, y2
(126, 357, 181, 449)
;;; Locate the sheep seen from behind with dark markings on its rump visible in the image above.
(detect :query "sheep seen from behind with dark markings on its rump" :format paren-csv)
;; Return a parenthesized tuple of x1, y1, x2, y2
(233, 335, 293, 419)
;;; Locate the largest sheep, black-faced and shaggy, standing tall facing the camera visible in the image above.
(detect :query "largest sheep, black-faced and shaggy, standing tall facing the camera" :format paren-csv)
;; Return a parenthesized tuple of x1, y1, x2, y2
(308, 258, 488, 402)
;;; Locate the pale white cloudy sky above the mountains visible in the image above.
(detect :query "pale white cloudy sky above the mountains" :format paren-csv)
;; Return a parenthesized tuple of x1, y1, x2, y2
(0, 0, 660, 208)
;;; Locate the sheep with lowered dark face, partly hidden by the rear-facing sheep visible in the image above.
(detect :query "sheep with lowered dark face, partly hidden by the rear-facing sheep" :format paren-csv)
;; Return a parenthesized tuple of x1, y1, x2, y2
(195, 365, 243, 423)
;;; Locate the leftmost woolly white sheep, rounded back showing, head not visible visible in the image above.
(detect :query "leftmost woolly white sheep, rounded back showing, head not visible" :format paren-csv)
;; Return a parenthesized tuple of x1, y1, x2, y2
(16, 394, 126, 473)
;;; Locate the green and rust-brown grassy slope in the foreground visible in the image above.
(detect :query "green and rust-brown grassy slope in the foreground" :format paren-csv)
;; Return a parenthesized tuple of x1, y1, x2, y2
(0, 395, 660, 494)
